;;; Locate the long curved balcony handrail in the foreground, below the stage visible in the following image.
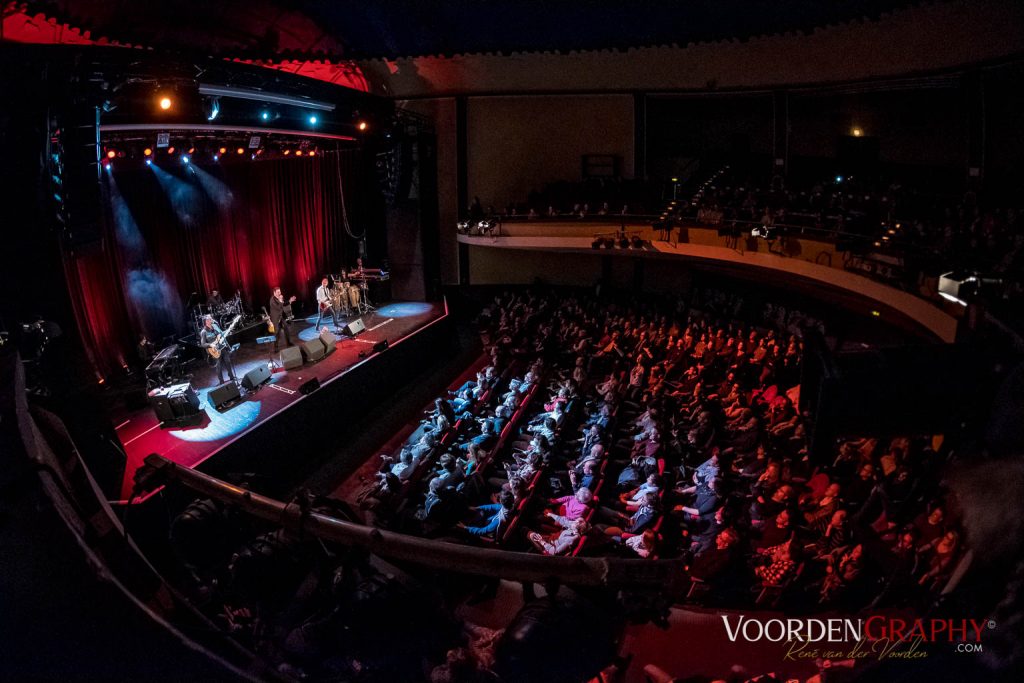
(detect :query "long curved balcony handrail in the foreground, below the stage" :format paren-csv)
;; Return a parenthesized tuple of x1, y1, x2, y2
(145, 454, 686, 592)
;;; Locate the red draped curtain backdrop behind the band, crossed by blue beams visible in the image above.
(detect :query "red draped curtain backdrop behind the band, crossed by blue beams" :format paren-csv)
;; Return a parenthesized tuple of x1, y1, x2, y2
(65, 151, 383, 375)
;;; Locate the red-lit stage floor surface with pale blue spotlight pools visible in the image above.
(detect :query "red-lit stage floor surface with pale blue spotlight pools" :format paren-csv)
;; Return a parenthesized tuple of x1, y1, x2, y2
(113, 301, 446, 502)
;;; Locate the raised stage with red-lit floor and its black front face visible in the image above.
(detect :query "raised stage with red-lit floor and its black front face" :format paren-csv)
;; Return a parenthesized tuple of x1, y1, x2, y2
(114, 301, 454, 503)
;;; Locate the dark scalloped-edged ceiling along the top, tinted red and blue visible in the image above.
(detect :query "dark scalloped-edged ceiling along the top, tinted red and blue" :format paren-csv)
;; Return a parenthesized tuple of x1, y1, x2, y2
(28, 0, 921, 58)
